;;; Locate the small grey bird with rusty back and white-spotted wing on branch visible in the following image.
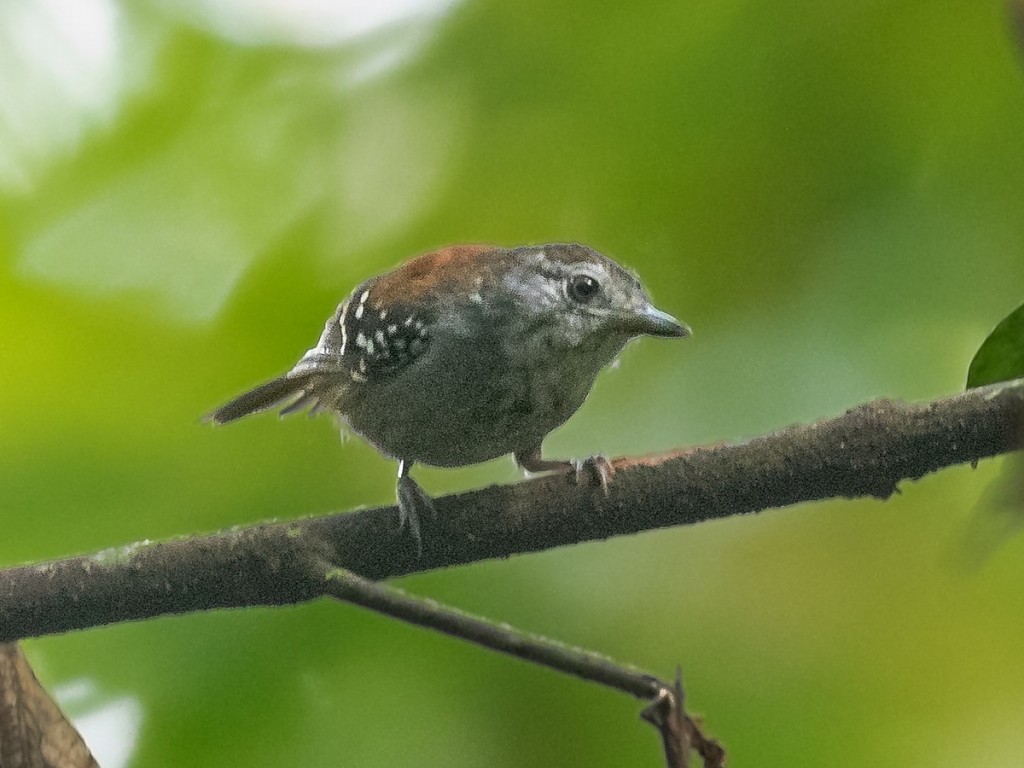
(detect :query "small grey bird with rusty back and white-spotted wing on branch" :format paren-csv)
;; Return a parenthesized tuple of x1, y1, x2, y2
(208, 243, 690, 551)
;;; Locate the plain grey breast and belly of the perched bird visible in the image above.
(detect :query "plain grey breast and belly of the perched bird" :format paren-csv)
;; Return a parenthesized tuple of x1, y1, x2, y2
(343, 315, 617, 466)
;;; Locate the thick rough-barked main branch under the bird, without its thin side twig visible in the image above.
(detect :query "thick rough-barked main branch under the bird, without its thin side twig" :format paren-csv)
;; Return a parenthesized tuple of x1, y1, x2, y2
(0, 380, 1024, 642)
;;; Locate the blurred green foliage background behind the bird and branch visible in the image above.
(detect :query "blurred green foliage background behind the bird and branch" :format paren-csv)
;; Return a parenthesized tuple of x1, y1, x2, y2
(0, 0, 1024, 768)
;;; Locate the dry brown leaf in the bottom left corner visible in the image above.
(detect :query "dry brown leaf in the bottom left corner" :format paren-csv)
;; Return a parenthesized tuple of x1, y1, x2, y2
(0, 643, 98, 768)
